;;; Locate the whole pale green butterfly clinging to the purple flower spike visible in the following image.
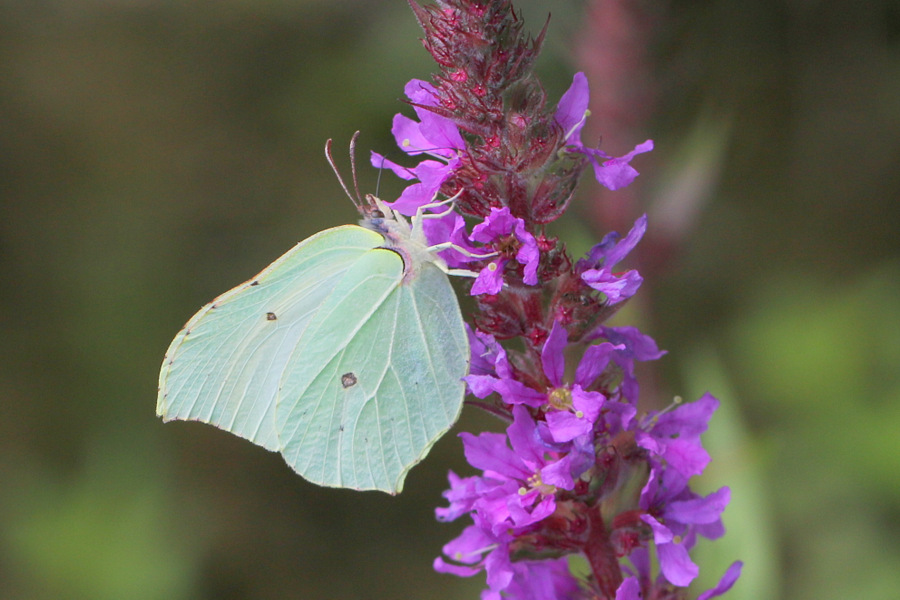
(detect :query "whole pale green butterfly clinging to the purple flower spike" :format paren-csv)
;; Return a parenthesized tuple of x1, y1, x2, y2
(156, 138, 469, 494)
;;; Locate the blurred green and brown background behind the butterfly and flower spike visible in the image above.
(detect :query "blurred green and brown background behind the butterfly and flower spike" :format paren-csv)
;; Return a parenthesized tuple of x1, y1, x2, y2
(0, 0, 900, 600)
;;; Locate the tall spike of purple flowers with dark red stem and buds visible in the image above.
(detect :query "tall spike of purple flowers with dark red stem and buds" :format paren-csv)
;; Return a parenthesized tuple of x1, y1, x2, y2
(372, 0, 741, 600)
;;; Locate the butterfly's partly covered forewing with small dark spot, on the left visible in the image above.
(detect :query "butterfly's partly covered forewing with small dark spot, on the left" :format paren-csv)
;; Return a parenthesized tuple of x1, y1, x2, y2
(156, 225, 384, 450)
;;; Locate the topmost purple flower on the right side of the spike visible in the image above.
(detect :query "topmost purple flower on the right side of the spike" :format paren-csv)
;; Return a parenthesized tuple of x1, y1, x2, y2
(555, 72, 653, 190)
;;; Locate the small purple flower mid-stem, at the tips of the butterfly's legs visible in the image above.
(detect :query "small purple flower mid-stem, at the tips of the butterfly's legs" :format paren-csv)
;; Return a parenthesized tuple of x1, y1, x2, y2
(469, 206, 541, 296)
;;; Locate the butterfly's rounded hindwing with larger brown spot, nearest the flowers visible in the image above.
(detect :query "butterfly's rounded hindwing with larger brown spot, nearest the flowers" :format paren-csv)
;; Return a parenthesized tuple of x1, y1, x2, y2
(276, 255, 469, 493)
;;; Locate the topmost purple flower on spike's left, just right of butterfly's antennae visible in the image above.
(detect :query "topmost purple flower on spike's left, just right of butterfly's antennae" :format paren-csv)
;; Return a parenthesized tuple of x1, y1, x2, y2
(371, 79, 465, 215)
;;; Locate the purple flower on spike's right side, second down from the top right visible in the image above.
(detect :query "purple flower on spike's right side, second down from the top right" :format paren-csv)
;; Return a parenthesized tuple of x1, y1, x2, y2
(579, 215, 647, 304)
